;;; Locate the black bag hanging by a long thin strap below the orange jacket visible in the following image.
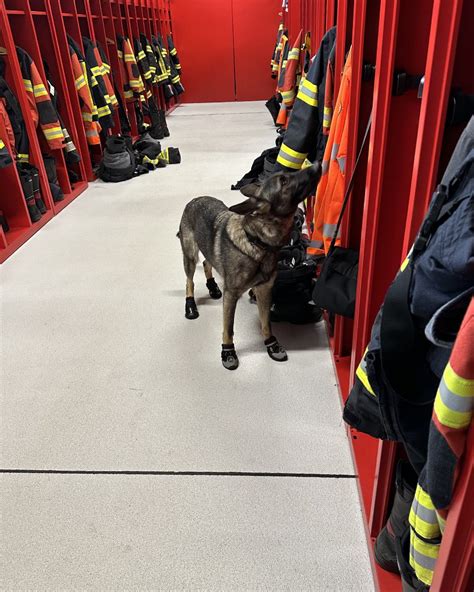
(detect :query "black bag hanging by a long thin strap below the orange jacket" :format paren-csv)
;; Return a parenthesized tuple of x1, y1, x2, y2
(313, 116, 372, 319)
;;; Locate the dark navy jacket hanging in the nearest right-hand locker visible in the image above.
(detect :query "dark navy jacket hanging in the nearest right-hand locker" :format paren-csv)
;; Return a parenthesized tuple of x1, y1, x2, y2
(344, 117, 474, 473)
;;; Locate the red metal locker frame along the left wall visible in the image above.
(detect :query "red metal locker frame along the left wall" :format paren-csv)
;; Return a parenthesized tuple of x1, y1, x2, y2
(0, 0, 178, 263)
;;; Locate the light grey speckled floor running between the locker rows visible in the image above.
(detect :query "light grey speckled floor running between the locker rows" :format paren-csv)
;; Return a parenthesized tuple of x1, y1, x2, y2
(0, 103, 373, 591)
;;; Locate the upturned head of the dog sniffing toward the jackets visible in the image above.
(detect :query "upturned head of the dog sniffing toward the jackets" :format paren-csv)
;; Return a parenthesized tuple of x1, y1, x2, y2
(230, 163, 321, 218)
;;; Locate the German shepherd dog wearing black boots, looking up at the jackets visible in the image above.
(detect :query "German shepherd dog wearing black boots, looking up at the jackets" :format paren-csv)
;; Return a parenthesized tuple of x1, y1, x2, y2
(178, 163, 321, 370)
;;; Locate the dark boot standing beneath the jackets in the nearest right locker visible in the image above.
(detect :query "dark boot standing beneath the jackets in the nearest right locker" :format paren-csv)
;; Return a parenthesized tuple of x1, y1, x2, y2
(375, 460, 417, 573)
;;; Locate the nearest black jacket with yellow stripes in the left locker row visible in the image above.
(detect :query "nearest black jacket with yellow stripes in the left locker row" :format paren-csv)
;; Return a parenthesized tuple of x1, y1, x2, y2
(82, 37, 115, 131)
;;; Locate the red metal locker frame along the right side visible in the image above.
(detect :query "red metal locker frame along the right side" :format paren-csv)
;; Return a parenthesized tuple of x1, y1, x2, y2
(287, 0, 474, 592)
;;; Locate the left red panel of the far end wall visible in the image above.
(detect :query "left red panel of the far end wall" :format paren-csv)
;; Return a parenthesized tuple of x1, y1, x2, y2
(171, 0, 237, 103)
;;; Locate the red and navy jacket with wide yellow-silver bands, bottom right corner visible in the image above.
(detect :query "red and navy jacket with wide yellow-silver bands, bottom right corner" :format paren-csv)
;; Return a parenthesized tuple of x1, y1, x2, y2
(409, 298, 474, 586)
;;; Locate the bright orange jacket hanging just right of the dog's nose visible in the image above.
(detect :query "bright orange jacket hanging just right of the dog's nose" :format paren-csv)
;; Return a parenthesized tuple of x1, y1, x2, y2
(308, 51, 352, 255)
